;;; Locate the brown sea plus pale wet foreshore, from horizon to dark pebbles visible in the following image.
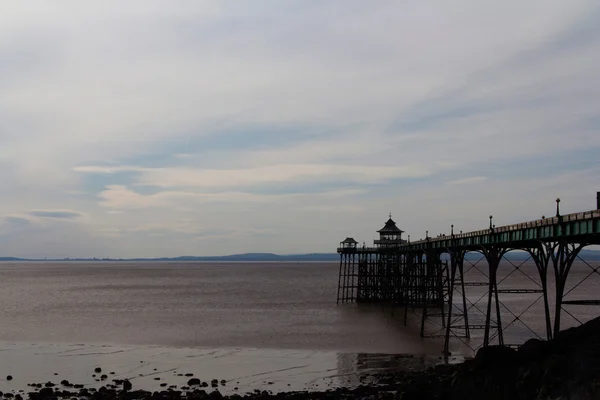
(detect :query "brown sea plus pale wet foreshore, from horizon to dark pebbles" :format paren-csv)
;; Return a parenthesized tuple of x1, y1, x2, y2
(0, 262, 460, 393)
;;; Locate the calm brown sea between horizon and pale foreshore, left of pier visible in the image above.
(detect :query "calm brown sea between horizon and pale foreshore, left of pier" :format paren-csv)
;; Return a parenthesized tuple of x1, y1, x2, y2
(0, 262, 439, 354)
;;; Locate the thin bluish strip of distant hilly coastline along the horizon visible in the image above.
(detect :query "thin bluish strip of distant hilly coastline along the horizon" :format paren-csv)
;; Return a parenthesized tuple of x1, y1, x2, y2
(0, 249, 600, 262)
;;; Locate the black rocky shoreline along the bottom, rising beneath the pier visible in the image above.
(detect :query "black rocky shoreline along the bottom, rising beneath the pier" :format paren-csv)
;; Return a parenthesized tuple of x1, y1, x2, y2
(7, 318, 600, 400)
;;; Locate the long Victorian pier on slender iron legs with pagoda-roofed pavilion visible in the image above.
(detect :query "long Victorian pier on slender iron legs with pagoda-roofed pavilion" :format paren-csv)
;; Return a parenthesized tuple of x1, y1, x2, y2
(337, 192, 600, 356)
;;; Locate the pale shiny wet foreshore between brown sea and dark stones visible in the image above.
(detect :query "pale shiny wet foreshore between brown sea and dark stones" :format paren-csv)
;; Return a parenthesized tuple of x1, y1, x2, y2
(0, 343, 460, 395)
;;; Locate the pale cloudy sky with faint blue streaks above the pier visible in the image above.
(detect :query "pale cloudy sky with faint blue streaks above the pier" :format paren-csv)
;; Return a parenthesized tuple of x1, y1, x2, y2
(0, 0, 600, 258)
